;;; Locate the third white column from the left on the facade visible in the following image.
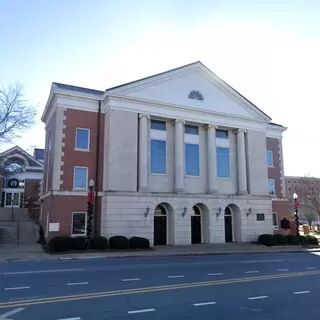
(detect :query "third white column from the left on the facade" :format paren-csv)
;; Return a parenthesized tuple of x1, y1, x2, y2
(207, 124, 218, 193)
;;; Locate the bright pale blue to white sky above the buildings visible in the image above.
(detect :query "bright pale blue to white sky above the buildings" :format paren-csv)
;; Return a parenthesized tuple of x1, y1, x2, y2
(0, 0, 320, 176)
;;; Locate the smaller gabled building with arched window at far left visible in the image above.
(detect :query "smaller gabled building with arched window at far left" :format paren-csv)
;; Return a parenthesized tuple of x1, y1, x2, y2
(0, 146, 43, 212)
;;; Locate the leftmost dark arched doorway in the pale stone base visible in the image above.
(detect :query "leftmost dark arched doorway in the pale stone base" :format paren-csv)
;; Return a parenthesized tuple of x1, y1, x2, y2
(153, 204, 168, 246)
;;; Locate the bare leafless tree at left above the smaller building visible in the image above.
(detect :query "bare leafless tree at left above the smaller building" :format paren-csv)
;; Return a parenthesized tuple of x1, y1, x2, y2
(0, 82, 36, 143)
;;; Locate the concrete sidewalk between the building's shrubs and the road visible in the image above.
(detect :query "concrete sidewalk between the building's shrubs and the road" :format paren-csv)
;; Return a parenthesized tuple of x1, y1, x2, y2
(0, 243, 320, 263)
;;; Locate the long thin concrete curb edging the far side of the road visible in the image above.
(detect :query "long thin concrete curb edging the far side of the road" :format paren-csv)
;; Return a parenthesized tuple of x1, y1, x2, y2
(0, 249, 320, 263)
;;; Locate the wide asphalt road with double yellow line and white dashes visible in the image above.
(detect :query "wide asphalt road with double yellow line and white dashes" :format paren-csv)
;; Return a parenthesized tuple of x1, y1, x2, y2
(0, 253, 320, 320)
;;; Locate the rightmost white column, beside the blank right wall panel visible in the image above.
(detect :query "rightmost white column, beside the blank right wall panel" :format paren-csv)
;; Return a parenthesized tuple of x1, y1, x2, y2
(235, 129, 248, 194)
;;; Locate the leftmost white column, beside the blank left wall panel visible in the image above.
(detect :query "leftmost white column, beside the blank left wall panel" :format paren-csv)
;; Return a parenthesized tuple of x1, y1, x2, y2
(139, 114, 150, 191)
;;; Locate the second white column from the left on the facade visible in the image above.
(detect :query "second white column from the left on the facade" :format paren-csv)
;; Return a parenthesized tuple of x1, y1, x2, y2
(174, 119, 185, 192)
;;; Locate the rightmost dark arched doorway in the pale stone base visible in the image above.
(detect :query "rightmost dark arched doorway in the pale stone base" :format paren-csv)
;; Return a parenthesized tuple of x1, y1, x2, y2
(224, 204, 241, 242)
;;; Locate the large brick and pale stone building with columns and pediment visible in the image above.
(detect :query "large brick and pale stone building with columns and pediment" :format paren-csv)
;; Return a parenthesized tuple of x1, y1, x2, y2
(41, 62, 288, 245)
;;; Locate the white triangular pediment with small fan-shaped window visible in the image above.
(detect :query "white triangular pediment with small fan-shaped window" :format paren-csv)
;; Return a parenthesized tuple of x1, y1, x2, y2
(106, 62, 271, 122)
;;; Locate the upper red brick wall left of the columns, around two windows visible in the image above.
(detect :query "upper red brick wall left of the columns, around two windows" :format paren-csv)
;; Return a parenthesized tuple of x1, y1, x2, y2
(60, 109, 105, 190)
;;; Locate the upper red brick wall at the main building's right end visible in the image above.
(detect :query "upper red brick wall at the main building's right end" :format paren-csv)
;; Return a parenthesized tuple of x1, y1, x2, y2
(267, 138, 284, 198)
